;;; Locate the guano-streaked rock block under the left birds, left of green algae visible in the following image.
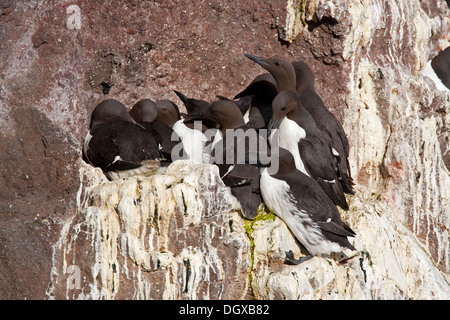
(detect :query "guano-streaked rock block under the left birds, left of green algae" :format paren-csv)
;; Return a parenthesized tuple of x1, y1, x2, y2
(52, 160, 251, 299)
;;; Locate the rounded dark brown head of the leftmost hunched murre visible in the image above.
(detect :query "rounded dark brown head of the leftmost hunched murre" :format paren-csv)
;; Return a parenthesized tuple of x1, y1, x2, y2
(89, 99, 135, 129)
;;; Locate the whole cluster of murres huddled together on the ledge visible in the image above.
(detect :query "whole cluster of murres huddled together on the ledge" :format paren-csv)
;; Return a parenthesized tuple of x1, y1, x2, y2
(83, 54, 355, 264)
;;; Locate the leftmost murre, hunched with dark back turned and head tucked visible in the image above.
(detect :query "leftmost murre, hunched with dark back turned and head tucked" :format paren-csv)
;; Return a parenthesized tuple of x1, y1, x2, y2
(83, 99, 163, 180)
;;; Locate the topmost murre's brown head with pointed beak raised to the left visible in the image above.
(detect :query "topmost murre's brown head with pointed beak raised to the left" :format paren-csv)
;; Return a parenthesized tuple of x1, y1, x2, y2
(245, 54, 295, 92)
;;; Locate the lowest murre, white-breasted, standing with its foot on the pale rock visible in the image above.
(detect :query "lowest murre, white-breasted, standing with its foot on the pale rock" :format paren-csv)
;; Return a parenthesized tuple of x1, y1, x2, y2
(260, 148, 356, 264)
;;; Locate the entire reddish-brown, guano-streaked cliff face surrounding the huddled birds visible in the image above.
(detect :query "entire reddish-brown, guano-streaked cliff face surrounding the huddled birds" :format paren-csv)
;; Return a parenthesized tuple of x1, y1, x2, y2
(0, 0, 450, 299)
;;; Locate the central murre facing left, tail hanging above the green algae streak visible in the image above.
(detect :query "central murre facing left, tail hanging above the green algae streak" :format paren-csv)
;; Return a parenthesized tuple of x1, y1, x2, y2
(197, 100, 266, 219)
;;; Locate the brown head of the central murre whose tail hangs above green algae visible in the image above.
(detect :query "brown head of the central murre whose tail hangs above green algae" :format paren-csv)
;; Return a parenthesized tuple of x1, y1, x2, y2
(200, 100, 245, 130)
